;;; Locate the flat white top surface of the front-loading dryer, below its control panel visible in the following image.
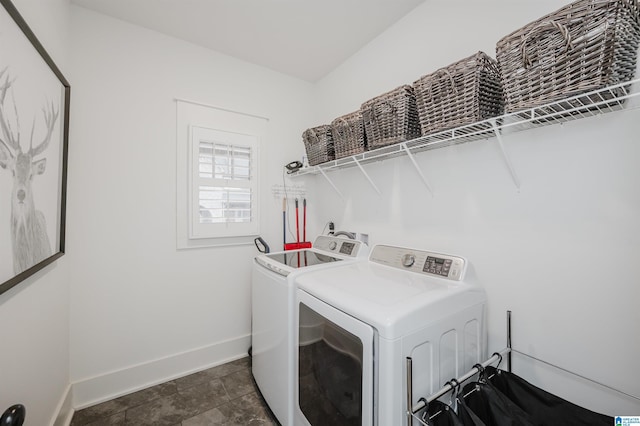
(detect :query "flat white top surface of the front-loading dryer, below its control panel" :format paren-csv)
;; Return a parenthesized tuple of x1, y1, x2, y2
(296, 261, 486, 339)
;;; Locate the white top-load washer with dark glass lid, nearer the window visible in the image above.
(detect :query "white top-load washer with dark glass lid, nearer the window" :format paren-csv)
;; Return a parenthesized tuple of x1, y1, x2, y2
(251, 235, 369, 426)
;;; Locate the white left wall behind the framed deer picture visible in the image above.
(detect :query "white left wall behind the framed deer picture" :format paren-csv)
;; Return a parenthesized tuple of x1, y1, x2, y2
(0, 0, 69, 426)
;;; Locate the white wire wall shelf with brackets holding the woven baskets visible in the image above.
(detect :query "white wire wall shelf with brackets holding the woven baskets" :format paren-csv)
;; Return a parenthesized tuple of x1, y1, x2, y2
(291, 79, 640, 193)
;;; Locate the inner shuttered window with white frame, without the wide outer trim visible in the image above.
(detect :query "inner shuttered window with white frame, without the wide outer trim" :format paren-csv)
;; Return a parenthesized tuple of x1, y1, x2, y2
(189, 126, 258, 238)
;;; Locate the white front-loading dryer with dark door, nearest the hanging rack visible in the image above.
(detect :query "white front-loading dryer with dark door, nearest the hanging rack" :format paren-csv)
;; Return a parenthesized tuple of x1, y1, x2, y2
(294, 245, 486, 426)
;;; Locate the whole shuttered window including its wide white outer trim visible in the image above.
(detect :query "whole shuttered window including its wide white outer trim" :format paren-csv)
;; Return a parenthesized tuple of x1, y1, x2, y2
(176, 100, 268, 249)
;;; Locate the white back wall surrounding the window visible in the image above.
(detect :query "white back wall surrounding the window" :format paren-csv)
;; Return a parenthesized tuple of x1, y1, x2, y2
(69, 6, 313, 408)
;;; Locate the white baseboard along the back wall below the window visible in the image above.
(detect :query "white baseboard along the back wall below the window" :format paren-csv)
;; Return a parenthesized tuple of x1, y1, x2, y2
(70, 334, 251, 412)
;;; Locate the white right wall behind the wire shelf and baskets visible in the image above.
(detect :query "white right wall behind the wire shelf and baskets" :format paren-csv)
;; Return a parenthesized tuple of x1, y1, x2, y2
(304, 0, 640, 415)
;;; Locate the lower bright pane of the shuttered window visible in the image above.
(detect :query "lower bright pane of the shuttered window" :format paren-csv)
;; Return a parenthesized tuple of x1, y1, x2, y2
(199, 186, 251, 223)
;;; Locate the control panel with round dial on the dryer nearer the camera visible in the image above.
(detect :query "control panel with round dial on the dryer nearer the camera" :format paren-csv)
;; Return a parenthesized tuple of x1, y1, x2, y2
(369, 245, 467, 281)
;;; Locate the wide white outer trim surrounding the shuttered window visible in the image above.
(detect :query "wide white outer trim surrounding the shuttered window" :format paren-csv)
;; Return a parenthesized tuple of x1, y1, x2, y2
(175, 99, 269, 249)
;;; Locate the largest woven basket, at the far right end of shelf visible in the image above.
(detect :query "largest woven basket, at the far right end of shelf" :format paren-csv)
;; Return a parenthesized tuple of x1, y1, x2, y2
(496, 0, 640, 112)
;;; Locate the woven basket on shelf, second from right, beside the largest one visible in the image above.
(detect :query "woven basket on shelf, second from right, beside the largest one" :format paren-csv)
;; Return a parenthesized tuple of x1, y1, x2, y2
(413, 52, 504, 135)
